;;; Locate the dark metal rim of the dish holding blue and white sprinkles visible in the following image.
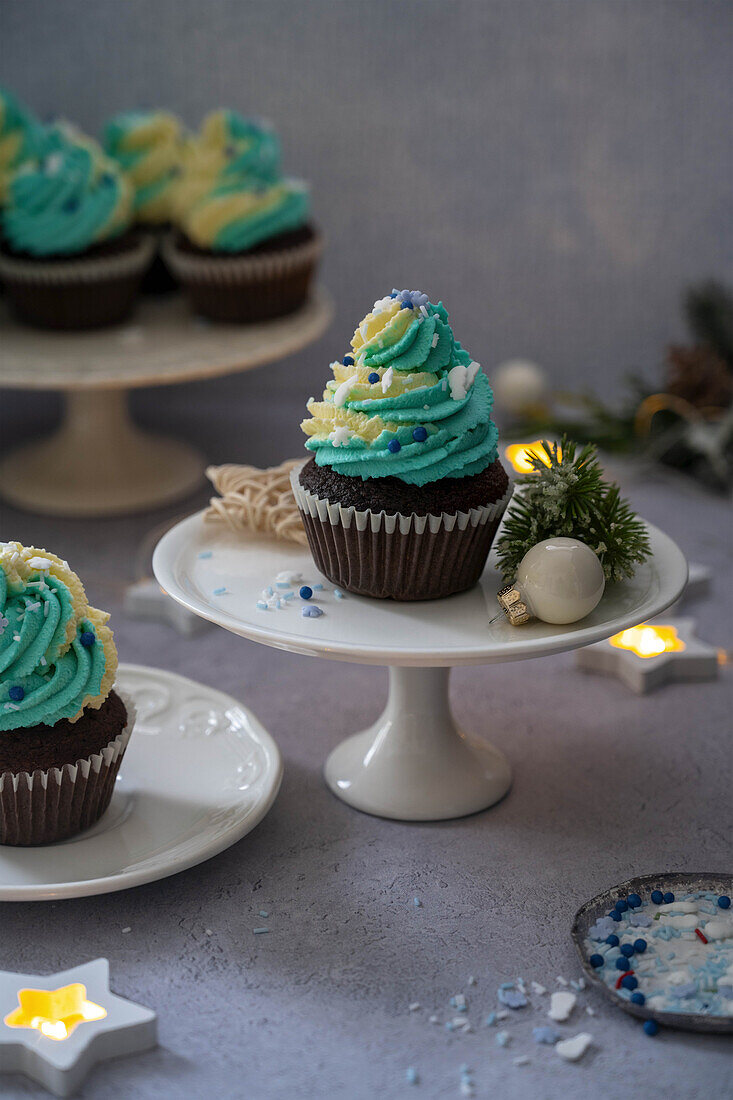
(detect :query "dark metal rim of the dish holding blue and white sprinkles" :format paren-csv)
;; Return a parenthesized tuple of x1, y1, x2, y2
(571, 871, 733, 1035)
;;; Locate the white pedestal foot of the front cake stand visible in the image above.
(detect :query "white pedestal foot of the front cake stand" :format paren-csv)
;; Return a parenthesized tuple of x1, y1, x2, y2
(325, 666, 512, 821)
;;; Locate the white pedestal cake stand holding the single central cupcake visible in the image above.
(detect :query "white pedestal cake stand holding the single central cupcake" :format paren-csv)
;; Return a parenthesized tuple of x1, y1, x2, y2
(153, 513, 687, 821)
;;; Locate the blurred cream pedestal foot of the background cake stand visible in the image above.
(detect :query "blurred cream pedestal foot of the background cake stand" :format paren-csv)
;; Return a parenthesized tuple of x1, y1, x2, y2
(0, 389, 205, 516)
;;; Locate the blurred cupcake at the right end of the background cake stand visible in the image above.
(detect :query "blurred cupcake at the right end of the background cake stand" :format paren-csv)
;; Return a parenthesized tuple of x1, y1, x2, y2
(164, 110, 321, 321)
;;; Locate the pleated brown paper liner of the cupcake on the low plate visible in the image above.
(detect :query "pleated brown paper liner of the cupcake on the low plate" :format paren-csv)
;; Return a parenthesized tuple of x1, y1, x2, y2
(0, 688, 135, 847)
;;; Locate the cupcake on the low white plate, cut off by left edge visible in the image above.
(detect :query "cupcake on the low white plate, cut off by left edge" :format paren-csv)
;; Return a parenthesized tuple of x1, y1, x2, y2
(0, 542, 134, 846)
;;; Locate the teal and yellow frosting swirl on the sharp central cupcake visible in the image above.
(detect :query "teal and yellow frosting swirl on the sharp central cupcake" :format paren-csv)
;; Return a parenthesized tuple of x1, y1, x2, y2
(303, 290, 499, 485)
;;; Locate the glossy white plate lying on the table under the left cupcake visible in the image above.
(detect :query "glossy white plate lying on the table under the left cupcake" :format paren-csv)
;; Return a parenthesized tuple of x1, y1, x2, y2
(0, 664, 283, 901)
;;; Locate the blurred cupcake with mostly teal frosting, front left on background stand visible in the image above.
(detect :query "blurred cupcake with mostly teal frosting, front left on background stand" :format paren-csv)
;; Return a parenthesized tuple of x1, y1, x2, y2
(0, 124, 153, 329)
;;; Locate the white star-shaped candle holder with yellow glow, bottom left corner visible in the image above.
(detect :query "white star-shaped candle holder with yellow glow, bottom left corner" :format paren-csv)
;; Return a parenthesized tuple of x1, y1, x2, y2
(0, 959, 157, 1097)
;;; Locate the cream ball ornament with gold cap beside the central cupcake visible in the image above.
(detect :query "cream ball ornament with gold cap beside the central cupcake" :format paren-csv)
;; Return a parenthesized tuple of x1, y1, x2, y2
(496, 536, 605, 626)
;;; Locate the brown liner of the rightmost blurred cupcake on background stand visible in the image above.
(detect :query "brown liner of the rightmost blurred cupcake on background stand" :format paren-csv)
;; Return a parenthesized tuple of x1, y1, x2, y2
(163, 226, 324, 322)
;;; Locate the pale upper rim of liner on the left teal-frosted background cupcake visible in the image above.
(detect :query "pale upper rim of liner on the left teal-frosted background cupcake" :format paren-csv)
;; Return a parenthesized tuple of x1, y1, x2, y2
(0, 233, 156, 286)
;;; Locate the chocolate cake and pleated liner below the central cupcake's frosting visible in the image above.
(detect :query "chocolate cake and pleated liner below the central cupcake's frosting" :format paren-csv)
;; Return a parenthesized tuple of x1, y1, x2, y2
(296, 460, 510, 601)
